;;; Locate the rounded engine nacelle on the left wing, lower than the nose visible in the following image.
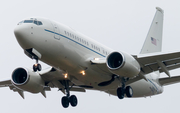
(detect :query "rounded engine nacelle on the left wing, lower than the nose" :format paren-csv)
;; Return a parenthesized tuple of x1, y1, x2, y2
(11, 68, 45, 93)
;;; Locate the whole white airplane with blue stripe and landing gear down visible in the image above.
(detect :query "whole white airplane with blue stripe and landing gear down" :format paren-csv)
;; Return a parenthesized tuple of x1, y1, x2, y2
(0, 7, 180, 108)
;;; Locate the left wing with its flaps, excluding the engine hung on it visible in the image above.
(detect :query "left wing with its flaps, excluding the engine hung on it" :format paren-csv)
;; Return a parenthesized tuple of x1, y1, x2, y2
(0, 67, 86, 98)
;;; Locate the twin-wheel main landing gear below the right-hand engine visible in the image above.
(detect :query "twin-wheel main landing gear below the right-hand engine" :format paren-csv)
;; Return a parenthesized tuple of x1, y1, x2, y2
(117, 78, 133, 99)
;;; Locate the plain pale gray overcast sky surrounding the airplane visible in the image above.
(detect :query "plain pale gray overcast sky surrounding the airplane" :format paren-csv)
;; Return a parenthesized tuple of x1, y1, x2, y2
(0, 0, 180, 113)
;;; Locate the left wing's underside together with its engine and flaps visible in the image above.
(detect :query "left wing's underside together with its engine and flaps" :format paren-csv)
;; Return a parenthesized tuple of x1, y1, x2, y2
(0, 67, 85, 98)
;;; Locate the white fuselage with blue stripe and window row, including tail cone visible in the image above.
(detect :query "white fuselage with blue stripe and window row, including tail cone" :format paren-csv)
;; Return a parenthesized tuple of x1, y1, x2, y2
(14, 18, 163, 97)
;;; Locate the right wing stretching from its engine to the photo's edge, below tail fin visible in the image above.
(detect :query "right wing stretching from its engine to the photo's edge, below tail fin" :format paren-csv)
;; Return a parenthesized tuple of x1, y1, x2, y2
(134, 52, 180, 75)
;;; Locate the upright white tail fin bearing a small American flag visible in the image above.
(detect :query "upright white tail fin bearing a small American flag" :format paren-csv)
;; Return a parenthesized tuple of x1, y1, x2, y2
(140, 7, 164, 54)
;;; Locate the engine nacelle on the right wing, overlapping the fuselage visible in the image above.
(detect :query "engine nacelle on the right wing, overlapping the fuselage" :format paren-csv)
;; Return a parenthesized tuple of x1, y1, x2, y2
(106, 52, 140, 78)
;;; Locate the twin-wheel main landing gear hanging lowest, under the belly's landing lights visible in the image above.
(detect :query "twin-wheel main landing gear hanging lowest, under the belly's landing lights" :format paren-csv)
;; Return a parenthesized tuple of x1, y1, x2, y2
(61, 81, 78, 108)
